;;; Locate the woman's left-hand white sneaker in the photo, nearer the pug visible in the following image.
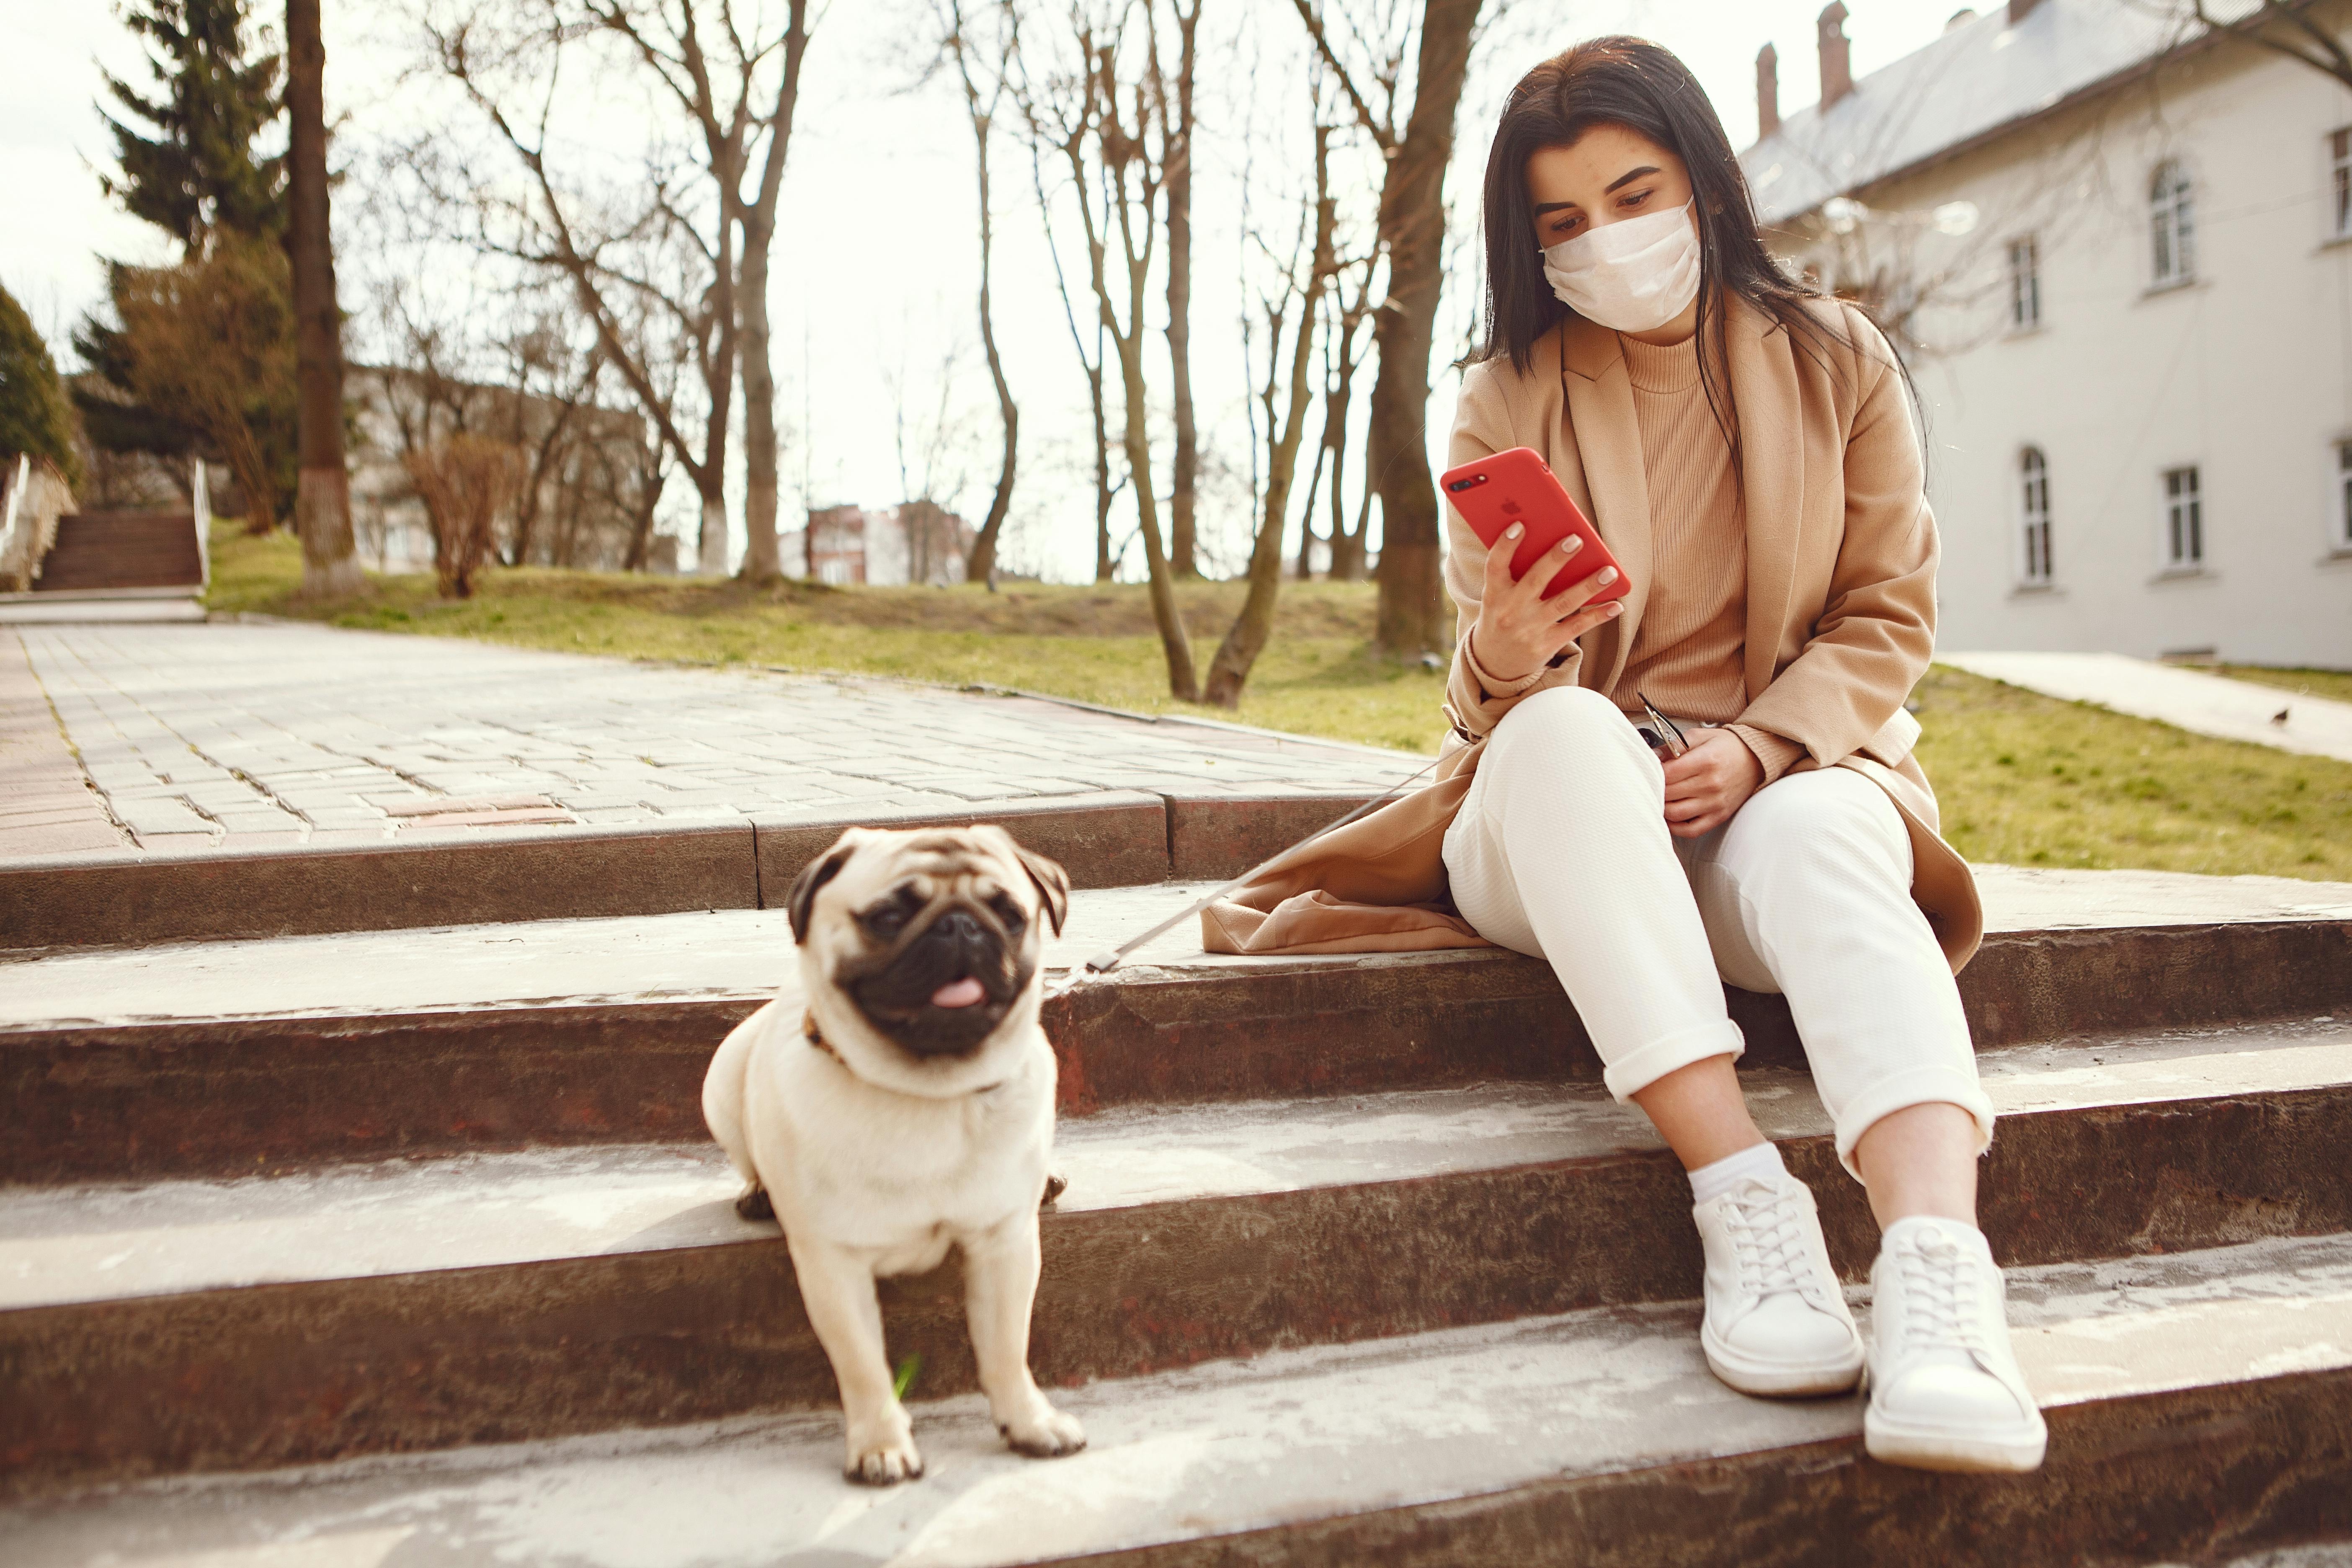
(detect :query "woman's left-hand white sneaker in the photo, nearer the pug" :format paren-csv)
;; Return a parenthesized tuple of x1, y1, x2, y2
(1691, 1176, 1863, 1394)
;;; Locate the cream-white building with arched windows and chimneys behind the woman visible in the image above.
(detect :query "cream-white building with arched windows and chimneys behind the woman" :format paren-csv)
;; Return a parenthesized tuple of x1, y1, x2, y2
(1741, 0, 2352, 668)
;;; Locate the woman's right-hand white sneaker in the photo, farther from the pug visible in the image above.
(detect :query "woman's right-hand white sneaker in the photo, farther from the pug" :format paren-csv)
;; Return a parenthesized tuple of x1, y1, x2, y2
(1863, 1215, 2049, 1472)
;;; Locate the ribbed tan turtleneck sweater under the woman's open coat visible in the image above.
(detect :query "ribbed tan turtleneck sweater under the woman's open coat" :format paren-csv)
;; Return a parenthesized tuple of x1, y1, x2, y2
(1609, 334, 1804, 781)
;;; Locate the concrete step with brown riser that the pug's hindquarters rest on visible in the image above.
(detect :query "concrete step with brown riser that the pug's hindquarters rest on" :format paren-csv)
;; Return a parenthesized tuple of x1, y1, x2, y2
(0, 1020, 2352, 1495)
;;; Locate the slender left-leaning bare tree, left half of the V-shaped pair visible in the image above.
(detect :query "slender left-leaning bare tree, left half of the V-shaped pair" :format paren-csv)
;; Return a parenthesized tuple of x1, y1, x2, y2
(1021, 0, 1199, 703)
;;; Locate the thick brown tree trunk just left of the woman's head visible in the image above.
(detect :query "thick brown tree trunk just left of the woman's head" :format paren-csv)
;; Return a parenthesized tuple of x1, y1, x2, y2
(1364, 0, 1479, 653)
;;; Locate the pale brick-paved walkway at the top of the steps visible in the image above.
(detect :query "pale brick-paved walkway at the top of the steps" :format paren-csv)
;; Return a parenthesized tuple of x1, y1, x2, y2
(0, 623, 1437, 860)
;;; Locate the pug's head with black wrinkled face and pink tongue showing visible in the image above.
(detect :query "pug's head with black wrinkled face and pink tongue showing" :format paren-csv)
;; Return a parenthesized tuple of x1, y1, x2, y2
(790, 828, 1070, 1060)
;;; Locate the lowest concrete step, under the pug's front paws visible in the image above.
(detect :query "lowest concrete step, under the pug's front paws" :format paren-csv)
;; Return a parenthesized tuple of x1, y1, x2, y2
(0, 1234, 2352, 1568)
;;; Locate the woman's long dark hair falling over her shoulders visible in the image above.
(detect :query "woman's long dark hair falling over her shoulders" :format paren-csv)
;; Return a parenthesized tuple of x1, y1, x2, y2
(1475, 38, 1910, 477)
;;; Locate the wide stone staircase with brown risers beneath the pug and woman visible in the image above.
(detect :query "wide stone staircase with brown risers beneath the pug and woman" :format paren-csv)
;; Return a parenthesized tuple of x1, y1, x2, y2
(0, 827, 2352, 1568)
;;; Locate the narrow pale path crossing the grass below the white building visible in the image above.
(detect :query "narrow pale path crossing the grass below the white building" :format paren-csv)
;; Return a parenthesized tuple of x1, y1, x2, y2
(1936, 653, 2352, 762)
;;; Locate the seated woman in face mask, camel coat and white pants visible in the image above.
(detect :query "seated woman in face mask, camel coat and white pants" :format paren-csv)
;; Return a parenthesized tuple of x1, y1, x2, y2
(1209, 38, 2046, 1469)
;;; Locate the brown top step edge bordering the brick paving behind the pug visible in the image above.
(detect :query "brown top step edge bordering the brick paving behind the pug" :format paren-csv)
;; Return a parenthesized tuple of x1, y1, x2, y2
(0, 790, 1371, 950)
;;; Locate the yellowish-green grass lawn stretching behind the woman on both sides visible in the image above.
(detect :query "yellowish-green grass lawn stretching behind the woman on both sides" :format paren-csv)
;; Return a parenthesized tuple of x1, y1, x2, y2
(209, 524, 2352, 882)
